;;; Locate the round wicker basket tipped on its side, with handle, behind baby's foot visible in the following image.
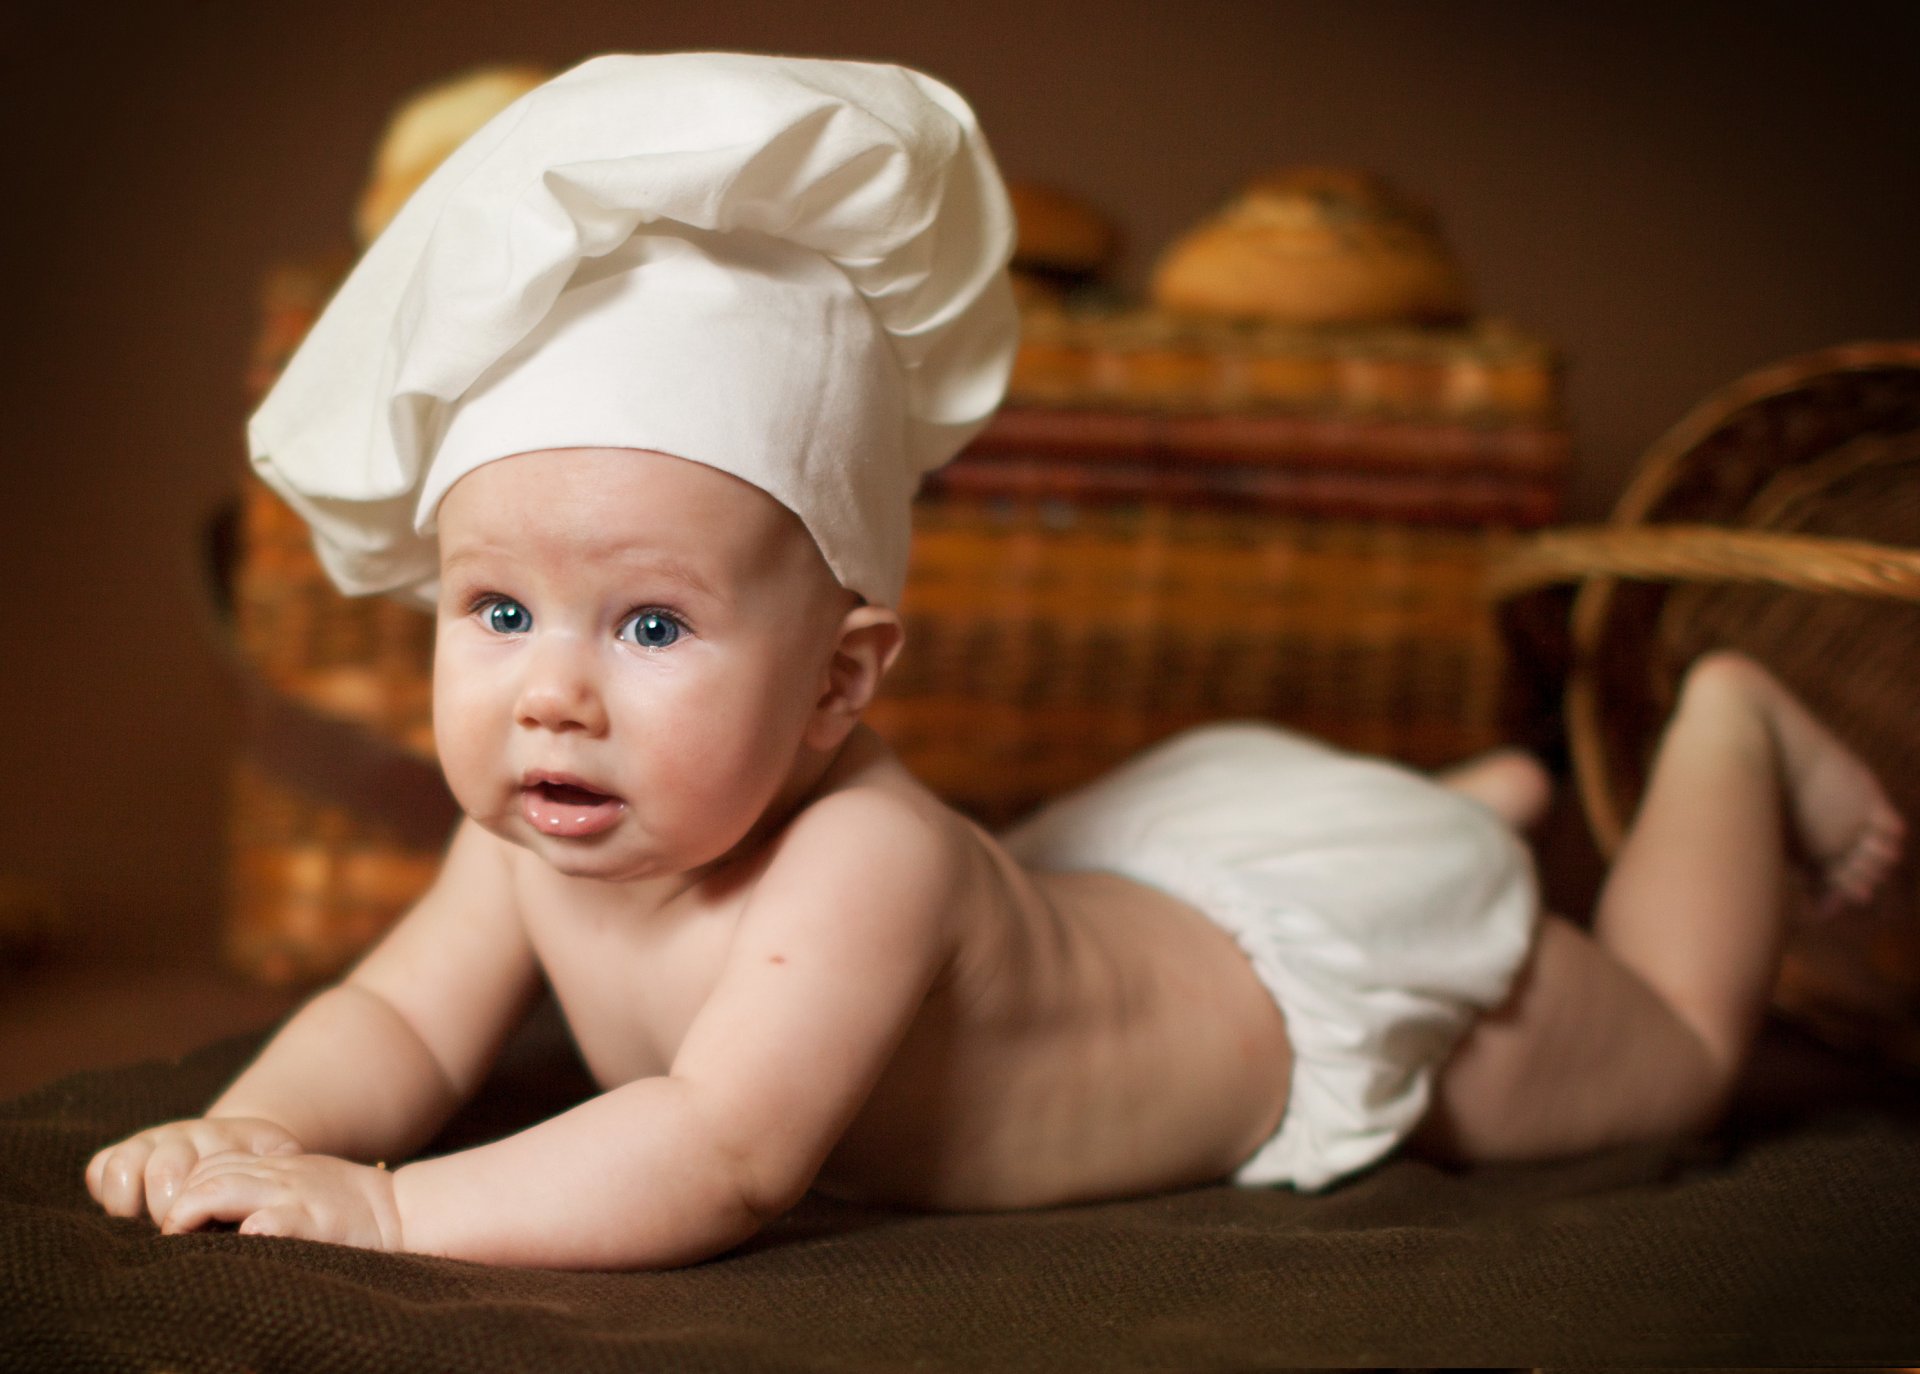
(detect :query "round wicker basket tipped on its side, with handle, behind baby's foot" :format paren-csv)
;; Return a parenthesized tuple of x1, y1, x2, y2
(1494, 344, 1920, 1067)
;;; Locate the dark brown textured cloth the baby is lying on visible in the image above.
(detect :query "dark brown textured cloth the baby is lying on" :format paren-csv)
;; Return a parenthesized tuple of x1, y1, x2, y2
(0, 1017, 1920, 1372)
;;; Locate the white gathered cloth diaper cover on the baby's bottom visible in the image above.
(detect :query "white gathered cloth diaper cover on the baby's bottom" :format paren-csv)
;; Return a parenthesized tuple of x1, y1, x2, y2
(1002, 723, 1538, 1190)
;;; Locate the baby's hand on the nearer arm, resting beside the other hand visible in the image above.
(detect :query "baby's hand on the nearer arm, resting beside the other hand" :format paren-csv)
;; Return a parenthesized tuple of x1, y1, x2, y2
(161, 1153, 403, 1249)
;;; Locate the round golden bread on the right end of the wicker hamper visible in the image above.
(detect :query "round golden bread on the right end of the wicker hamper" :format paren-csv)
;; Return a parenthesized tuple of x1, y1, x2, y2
(1150, 167, 1469, 324)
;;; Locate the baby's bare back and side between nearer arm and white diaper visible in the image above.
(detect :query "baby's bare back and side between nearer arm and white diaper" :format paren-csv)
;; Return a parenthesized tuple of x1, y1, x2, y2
(820, 859, 1290, 1209)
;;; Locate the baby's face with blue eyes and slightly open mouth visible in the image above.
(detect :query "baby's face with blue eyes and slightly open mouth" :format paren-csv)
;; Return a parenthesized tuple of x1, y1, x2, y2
(434, 449, 852, 881)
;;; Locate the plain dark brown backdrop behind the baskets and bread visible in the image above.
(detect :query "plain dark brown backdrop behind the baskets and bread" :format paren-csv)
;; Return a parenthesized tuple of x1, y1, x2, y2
(0, 0, 1920, 959)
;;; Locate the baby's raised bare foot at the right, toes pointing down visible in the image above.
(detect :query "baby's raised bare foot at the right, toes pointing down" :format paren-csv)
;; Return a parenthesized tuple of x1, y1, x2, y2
(1703, 652, 1907, 917)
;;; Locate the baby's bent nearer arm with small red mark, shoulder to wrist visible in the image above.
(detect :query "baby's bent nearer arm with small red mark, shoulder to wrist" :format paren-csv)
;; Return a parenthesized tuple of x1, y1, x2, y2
(167, 793, 958, 1268)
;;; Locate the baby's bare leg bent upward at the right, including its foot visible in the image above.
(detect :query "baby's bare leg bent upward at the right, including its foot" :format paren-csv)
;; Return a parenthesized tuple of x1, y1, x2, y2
(1417, 654, 1905, 1159)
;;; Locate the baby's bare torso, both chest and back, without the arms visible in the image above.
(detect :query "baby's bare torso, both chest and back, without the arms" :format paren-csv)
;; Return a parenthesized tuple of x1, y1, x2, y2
(520, 743, 1290, 1209)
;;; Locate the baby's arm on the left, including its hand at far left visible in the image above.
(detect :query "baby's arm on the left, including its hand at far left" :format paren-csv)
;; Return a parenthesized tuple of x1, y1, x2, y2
(86, 821, 536, 1222)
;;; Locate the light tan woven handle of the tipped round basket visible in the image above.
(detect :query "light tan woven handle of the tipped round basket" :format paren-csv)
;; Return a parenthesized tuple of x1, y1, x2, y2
(1486, 524, 1920, 601)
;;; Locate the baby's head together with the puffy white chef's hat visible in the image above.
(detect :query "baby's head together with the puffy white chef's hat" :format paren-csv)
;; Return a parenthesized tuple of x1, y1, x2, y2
(250, 54, 1018, 877)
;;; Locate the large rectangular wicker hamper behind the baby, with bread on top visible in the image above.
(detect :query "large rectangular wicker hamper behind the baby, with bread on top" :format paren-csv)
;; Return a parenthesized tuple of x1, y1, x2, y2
(227, 263, 1567, 981)
